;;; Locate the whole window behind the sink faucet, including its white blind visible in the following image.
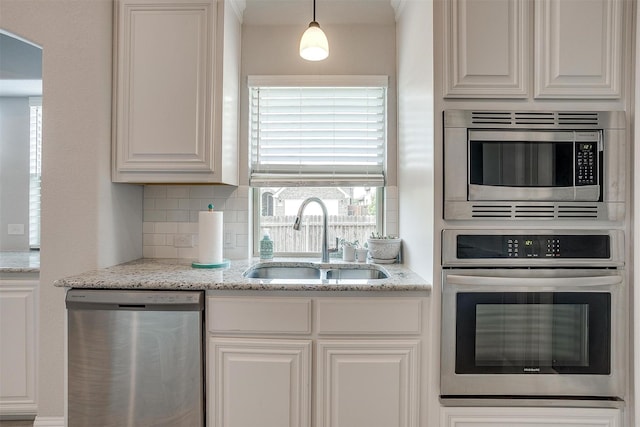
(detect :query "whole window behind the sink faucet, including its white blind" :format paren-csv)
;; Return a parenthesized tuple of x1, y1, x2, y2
(249, 76, 387, 255)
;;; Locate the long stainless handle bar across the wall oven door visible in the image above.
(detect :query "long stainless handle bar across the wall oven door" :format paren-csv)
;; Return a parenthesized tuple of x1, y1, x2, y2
(446, 274, 622, 288)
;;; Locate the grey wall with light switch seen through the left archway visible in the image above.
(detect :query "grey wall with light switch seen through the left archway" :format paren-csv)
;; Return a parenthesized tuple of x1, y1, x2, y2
(0, 97, 29, 251)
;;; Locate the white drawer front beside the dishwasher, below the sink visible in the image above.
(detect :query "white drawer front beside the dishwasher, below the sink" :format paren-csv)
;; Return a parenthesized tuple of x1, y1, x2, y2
(207, 297, 311, 334)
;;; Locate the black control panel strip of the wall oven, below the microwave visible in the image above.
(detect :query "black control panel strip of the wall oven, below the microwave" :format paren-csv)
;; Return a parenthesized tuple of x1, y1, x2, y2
(456, 234, 611, 259)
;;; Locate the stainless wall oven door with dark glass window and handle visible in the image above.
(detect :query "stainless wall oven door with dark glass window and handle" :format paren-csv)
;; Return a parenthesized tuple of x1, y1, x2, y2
(441, 269, 627, 398)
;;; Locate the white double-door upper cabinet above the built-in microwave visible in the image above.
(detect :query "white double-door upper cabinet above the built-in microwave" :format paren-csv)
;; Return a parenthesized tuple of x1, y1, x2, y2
(444, 0, 624, 99)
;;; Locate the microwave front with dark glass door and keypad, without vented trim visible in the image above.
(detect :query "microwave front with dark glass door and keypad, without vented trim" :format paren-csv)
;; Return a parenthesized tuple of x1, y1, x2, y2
(468, 129, 602, 201)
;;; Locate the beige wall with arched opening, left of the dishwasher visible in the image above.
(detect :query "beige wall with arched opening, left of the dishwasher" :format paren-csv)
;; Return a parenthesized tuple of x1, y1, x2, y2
(0, 0, 142, 418)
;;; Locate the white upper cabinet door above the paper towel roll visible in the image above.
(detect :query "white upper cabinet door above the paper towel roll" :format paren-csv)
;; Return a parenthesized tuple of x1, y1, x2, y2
(113, 0, 216, 182)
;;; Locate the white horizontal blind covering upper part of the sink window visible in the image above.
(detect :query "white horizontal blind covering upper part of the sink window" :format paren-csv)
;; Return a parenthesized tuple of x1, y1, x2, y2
(249, 76, 387, 187)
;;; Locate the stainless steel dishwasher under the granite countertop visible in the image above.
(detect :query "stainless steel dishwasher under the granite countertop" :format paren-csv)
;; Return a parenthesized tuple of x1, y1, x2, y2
(66, 289, 204, 427)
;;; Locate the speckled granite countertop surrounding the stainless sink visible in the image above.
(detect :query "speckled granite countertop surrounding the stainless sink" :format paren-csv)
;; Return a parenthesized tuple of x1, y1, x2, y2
(54, 258, 431, 292)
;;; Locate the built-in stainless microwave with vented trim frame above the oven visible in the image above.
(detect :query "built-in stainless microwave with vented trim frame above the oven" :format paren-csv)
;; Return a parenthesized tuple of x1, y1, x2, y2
(444, 110, 626, 221)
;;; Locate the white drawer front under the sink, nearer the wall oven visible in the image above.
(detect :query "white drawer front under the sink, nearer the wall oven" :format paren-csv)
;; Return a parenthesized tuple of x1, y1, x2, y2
(316, 298, 422, 335)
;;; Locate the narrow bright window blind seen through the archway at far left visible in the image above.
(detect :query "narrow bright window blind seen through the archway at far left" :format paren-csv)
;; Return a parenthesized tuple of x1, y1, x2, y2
(29, 97, 42, 249)
